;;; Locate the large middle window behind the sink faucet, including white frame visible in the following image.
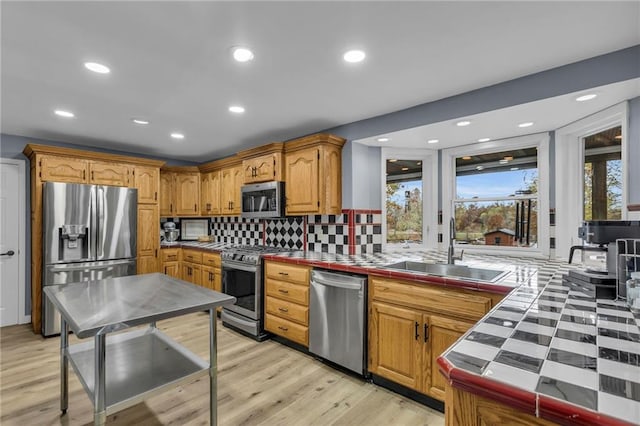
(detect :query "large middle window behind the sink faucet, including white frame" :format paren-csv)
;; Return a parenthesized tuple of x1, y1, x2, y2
(442, 134, 549, 255)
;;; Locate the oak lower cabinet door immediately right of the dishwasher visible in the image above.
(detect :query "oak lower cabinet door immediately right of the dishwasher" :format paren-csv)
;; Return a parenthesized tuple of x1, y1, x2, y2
(369, 302, 424, 391)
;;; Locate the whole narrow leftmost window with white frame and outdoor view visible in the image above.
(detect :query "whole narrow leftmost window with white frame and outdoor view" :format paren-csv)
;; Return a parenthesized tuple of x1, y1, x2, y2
(382, 148, 438, 249)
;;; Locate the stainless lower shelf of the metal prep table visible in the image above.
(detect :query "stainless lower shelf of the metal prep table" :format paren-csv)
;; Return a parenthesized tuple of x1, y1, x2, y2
(67, 327, 209, 415)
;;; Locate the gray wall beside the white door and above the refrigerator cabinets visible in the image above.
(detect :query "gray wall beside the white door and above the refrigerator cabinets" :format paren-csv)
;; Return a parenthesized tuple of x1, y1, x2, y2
(0, 133, 196, 315)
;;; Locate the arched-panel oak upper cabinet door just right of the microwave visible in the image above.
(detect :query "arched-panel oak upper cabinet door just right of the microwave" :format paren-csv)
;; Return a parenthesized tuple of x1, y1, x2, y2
(285, 148, 320, 215)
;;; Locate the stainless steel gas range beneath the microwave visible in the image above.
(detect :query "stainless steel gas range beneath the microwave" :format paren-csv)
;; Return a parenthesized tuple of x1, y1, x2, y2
(221, 245, 290, 340)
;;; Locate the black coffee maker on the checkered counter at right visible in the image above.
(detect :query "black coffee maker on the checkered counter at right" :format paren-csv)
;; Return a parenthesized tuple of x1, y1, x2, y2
(563, 220, 640, 299)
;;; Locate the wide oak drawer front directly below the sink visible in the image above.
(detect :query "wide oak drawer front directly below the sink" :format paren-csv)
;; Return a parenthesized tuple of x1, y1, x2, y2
(369, 277, 491, 319)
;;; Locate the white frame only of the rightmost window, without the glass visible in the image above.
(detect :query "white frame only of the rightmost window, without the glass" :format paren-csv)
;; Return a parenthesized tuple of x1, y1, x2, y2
(555, 101, 629, 259)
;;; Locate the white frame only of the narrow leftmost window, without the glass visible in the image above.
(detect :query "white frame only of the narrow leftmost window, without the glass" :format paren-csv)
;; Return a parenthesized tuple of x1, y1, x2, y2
(380, 147, 438, 251)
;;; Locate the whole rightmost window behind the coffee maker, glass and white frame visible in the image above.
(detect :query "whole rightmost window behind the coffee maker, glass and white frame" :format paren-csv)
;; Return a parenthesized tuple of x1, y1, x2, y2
(555, 102, 629, 259)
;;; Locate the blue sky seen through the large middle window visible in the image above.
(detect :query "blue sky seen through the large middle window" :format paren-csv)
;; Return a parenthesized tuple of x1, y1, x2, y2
(456, 169, 537, 199)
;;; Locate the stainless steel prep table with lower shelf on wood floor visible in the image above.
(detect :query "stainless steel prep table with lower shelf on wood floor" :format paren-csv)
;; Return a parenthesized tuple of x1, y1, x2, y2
(44, 273, 235, 425)
